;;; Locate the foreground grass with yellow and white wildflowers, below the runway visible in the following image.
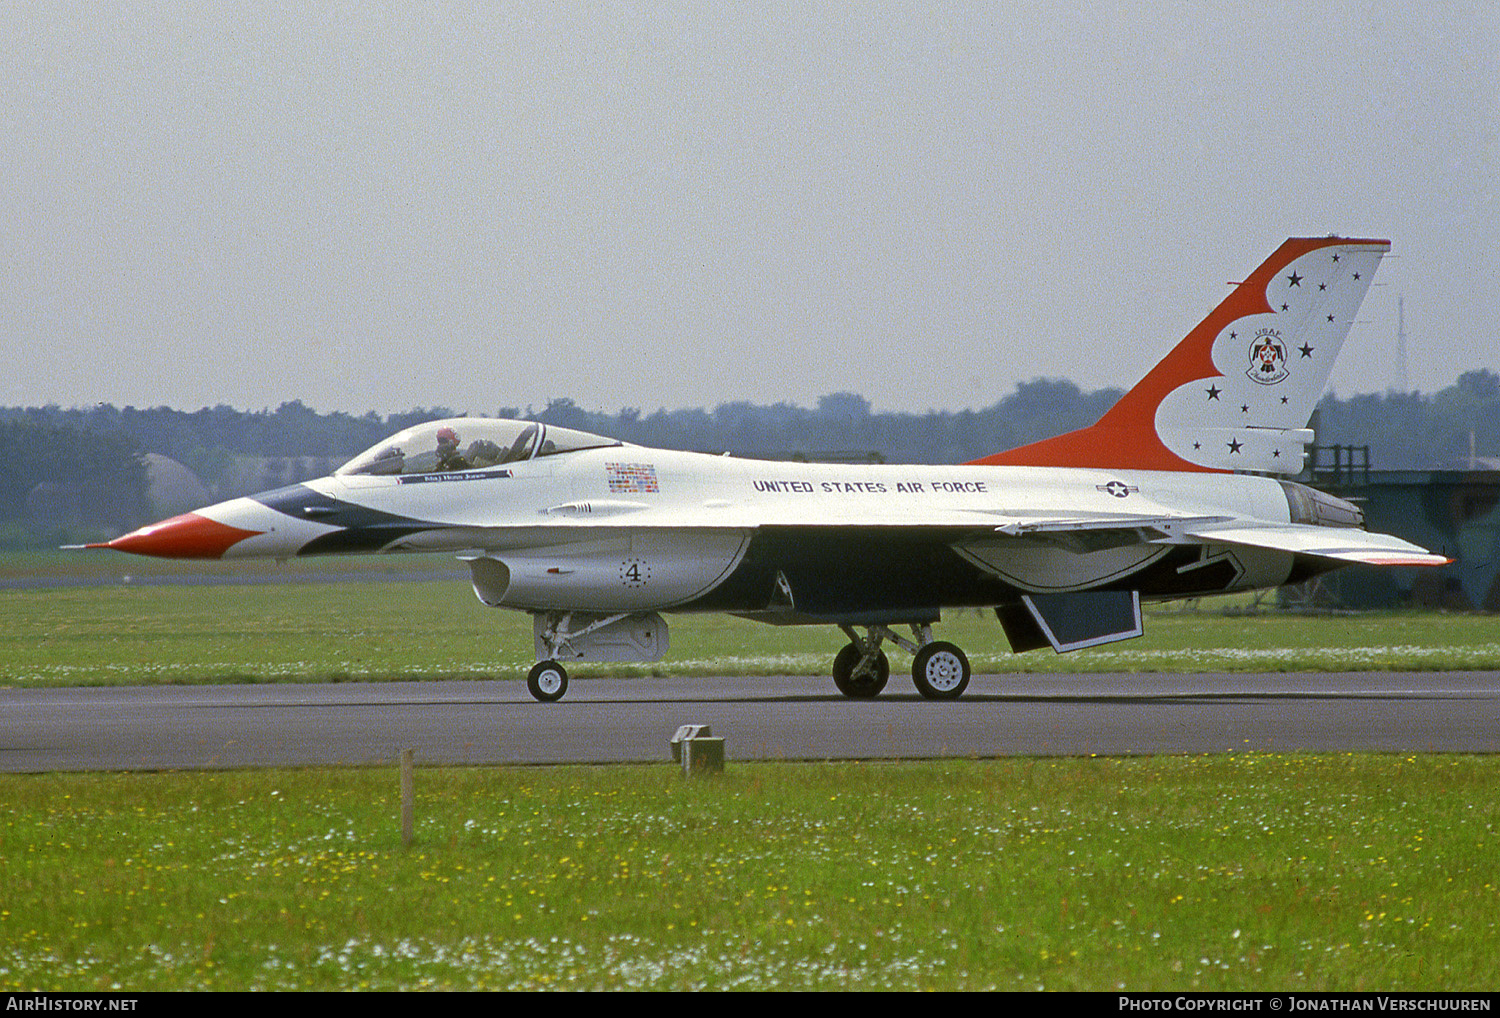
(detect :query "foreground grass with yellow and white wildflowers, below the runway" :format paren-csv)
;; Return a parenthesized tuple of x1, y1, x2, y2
(0, 754, 1500, 991)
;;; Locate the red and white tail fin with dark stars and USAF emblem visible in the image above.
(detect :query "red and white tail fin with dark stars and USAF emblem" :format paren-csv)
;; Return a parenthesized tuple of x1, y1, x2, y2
(974, 237, 1391, 474)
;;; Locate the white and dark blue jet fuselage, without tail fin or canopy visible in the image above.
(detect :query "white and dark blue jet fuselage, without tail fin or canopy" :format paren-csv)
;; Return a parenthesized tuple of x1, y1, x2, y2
(161, 445, 1314, 624)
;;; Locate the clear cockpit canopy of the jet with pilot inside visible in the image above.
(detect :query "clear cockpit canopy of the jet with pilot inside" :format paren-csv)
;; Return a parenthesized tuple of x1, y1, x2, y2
(335, 417, 620, 477)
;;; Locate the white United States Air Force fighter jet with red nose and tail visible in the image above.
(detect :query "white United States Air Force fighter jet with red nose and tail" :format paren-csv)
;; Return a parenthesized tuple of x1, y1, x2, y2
(89, 237, 1448, 700)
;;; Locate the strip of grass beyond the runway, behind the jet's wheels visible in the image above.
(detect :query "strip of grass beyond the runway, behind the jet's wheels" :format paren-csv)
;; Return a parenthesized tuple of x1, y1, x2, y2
(0, 570, 1500, 687)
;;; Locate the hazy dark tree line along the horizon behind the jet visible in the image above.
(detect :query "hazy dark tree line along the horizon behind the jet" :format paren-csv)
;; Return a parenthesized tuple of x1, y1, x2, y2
(0, 369, 1500, 542)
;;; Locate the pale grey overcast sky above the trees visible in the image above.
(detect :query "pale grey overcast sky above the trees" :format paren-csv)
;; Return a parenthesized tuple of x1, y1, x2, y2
(0, 0, 1500, 414)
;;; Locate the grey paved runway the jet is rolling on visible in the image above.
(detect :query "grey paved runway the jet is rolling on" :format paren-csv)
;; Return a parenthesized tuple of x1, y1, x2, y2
(0, 672, 1500, 772)
